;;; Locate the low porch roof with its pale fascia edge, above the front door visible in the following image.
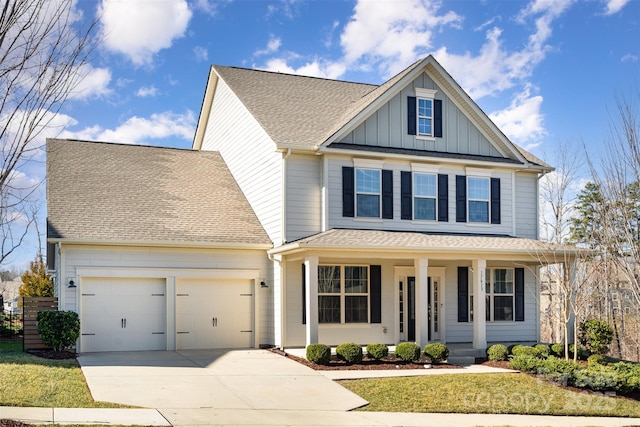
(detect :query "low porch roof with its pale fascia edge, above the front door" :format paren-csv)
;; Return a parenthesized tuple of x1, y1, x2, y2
(269, 229, 582, 264)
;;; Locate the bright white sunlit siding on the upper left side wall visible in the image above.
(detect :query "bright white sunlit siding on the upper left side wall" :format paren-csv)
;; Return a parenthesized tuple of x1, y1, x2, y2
(202, 78, 283, 244)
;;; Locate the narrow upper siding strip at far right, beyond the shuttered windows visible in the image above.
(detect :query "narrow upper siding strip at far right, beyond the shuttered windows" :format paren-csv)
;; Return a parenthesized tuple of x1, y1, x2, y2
(515, 172, 538, 239)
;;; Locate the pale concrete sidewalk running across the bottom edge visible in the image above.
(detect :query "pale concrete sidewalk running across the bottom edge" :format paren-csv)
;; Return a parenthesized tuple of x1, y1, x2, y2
(0, 407, 640, 427)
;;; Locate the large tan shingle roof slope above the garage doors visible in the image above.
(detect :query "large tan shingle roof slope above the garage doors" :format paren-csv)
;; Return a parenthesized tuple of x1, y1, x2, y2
(47, 139, 271, 247)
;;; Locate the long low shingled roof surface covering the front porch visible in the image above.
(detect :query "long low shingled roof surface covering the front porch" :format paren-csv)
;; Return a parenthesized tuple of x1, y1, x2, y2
(272, 229, 579, 258)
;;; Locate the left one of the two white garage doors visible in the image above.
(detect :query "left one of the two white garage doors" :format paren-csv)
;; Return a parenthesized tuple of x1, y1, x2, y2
(80, 278, 166, 352)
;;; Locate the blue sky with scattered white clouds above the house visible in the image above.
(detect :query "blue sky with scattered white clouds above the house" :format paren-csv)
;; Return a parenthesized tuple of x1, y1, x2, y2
(2, 0, 640, 267)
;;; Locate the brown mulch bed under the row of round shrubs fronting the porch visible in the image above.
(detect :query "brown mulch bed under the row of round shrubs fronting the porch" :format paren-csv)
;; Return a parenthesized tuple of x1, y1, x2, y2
(269, 348, 462, 371)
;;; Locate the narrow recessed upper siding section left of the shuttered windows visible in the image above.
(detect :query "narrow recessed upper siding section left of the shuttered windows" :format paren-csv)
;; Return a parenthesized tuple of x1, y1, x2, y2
(285, 155, 322, 241)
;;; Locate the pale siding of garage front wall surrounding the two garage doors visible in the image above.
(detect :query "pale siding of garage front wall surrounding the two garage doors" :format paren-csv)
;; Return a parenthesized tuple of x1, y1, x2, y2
(60, 245, 274, 344)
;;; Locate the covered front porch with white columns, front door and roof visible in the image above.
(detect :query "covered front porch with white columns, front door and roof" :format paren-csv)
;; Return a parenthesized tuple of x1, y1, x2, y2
(270, 230, 566, 350)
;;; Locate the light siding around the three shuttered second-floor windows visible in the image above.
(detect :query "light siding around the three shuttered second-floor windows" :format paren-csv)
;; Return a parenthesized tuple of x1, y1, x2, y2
(328, 157, 513, 235)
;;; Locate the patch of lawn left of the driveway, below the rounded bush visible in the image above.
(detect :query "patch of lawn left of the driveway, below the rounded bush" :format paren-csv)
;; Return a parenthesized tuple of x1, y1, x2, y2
(0, 352, 123, 408)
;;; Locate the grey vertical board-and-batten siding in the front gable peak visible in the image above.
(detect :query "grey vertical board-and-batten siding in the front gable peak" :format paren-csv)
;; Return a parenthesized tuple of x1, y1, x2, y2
(340, 73, 502, 157)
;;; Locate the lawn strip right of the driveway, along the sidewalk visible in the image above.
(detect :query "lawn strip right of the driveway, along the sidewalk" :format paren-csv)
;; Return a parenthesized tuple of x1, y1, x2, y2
(340, 374, 640, 417)
